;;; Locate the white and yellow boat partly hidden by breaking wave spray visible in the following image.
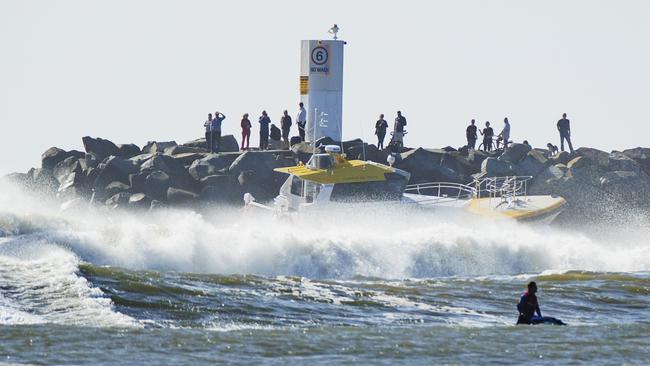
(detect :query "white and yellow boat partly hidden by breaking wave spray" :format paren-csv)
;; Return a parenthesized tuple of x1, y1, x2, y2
(244, 145, 566, 223)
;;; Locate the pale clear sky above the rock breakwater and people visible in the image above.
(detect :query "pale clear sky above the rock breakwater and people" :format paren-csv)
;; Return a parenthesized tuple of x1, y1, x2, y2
(0, 0, 650, 174)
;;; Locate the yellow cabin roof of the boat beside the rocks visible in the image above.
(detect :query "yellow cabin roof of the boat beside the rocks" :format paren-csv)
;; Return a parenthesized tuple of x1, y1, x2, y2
(274, 160, 394, 184)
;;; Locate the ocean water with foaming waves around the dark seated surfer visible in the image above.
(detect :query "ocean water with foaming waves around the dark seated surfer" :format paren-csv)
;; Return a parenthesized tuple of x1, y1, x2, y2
(0, 184, 650, 365)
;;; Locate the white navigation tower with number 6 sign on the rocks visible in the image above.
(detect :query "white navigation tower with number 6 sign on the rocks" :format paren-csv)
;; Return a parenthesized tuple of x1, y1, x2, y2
(300, 24, 346, 141)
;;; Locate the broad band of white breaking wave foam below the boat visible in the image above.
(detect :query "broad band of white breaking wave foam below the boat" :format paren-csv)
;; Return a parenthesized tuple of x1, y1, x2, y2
(0, 179, 650, 278)
